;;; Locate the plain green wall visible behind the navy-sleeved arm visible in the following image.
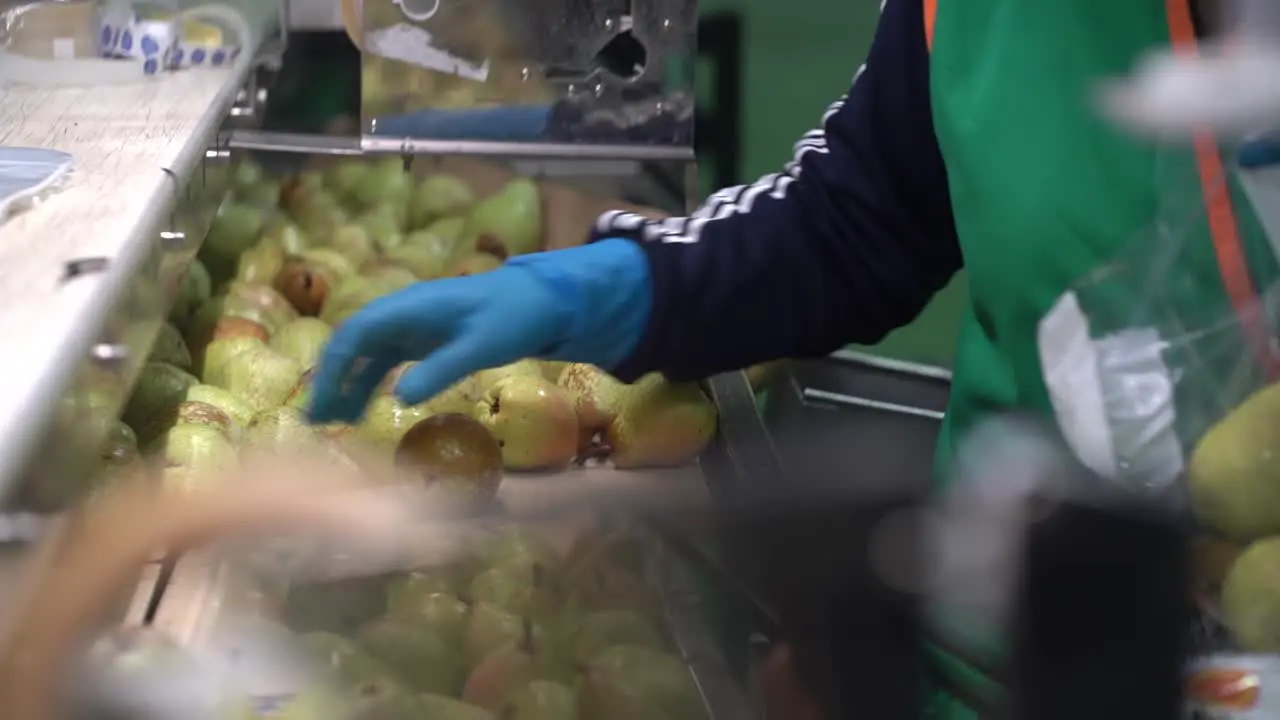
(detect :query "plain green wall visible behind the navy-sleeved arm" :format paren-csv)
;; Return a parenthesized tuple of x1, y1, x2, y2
(699, 0, 966, 366)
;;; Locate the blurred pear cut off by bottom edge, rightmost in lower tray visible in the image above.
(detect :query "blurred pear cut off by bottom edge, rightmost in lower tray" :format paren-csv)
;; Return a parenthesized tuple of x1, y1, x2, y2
(579, 644, 707, 720)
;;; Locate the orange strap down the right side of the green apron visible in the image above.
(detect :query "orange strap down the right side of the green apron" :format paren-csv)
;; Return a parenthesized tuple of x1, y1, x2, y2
(1167, 0, 1277, 379)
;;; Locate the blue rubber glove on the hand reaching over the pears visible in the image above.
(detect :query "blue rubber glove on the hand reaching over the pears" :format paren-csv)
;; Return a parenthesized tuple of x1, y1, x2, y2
(311, 238, 653, 423)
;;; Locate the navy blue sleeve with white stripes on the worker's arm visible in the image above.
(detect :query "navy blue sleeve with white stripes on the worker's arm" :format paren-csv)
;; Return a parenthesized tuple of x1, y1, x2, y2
(593, 0, 963, 380)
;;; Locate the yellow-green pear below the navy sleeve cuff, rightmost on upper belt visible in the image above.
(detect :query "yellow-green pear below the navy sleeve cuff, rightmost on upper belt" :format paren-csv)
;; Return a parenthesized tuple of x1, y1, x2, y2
(604, 373, 717, 468)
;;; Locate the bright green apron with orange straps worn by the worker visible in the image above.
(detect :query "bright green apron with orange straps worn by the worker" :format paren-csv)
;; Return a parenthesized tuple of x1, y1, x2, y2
(908, 0, 1275, 720)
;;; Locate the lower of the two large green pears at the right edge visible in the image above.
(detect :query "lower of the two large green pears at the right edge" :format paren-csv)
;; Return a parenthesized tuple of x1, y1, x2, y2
(1220, 538, 1280, 653)
